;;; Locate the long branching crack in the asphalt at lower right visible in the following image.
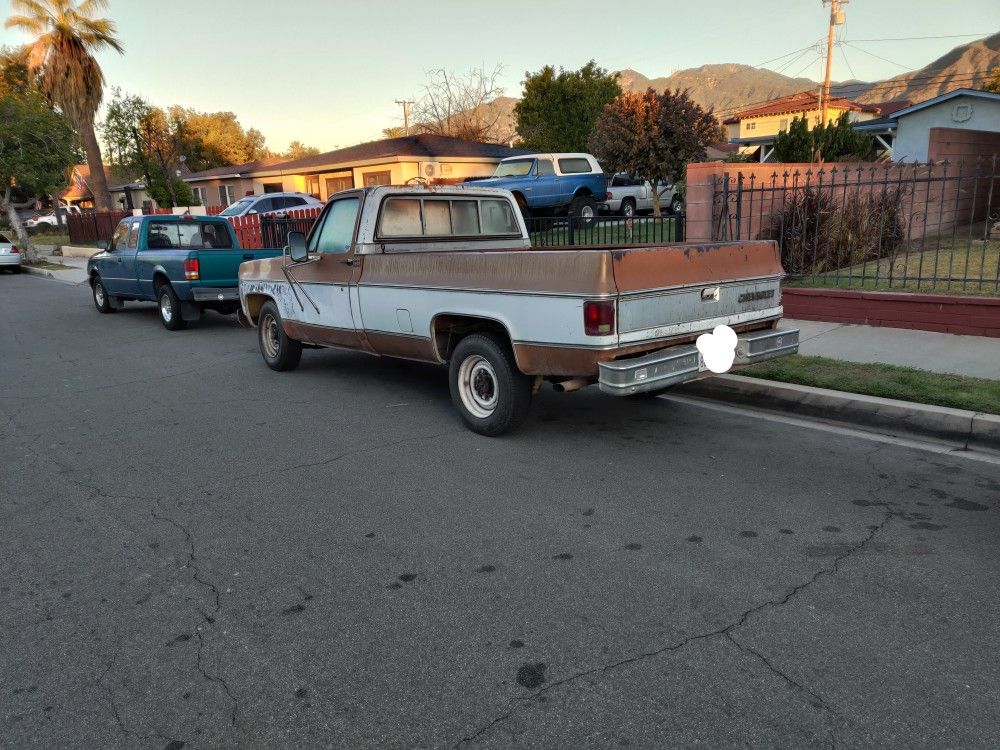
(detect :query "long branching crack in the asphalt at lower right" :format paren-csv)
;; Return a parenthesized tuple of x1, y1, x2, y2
(452, 446, 905, 750)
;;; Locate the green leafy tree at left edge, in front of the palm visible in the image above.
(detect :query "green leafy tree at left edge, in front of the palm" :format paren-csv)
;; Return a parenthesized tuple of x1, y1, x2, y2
(0, 52, 80, 261)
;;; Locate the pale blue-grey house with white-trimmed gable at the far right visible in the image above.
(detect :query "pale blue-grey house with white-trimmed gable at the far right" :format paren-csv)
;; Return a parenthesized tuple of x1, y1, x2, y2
(854, 88, 1000, 163)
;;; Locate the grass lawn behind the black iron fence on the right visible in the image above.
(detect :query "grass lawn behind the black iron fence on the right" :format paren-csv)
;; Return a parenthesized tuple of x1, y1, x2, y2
(785, 244, 1000, 297)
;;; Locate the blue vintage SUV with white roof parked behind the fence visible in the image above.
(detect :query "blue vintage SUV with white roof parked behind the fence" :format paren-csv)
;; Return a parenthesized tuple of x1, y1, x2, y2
(469, 154, 608, 226)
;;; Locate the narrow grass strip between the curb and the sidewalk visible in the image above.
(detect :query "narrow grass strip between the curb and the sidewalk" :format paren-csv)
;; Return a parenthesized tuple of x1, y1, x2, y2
(736, 354, 1000, 414)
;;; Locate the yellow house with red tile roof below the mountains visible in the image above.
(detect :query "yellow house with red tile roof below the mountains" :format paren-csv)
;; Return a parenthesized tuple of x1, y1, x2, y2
(722, 91, 879, 162)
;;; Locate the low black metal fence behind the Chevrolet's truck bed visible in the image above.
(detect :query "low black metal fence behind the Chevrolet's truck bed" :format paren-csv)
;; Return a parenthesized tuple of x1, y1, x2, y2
(525, 216, 684, 247)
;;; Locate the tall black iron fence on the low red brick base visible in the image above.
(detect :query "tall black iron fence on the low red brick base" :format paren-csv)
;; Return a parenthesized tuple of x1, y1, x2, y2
(712, 156, 1000, 295)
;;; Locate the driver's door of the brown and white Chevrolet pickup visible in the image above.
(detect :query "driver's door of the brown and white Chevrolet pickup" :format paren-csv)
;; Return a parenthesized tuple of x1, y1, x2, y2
(281, 193, 364, 349)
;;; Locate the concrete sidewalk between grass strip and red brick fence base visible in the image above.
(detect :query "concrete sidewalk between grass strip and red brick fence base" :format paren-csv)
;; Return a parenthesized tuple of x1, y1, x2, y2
(781, 318, 1000, 380)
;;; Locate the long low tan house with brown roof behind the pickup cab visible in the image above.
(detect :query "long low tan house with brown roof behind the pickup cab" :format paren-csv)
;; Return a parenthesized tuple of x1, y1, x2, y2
(184, 135, 527, 206)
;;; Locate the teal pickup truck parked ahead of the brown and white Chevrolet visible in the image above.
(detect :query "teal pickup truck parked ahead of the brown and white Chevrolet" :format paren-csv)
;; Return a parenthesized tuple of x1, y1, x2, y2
(87, 215, 282, 331)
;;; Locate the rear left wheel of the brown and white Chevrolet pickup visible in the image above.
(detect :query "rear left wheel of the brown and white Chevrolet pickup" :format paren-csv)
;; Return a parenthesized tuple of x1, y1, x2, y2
(448, 333, 531, 437)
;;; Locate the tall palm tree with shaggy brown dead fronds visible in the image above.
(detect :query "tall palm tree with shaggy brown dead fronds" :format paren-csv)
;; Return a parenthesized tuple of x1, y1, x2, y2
(4, 0, 124, 211)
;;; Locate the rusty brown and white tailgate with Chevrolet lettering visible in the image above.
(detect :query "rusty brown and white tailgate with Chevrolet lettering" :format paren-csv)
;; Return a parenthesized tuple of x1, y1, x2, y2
(611, 241, 784, 344)
